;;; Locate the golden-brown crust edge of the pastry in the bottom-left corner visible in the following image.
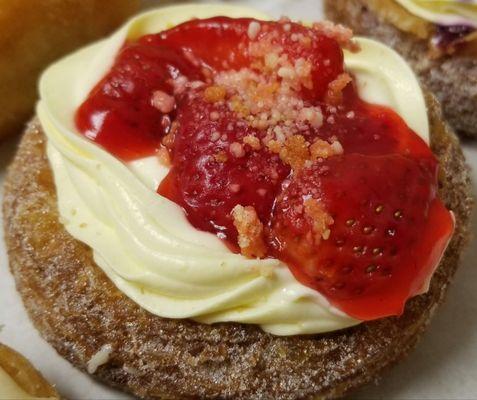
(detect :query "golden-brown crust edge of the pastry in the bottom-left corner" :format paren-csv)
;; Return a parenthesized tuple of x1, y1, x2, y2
(0, 343, 60, 399)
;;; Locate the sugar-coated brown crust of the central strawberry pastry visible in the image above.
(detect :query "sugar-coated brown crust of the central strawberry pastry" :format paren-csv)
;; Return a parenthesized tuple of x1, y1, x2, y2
(4, 93, 472, 399)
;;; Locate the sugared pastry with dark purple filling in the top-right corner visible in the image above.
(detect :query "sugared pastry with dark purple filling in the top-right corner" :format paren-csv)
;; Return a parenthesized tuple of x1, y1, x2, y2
(325, 0, 477, 137)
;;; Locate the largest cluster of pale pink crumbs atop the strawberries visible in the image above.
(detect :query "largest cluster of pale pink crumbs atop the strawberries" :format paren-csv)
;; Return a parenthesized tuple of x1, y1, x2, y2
(204, 20, 323, 149)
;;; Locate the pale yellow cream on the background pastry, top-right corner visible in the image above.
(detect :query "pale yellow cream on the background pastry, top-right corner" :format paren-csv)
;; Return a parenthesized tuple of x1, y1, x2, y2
(395, 0, 477, 27)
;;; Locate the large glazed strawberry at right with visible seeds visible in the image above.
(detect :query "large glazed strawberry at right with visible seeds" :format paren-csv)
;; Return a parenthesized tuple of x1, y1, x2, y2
(272, 154, 454, 320)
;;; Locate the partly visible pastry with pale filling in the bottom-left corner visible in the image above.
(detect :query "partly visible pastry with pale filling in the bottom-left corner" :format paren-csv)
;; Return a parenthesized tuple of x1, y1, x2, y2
(0, 343, 60, 400)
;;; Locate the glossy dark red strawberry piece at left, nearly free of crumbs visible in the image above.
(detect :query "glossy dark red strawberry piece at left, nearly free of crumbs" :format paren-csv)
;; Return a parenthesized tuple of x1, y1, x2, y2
(76, 42, 202, 161)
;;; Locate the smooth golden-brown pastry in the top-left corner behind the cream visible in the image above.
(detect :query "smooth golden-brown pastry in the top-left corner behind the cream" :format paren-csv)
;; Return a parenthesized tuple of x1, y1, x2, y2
(0, 0, 139, 139)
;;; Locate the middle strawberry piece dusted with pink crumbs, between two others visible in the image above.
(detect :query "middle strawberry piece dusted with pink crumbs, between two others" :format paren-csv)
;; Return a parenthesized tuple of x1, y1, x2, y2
(158, 94, 290, 247)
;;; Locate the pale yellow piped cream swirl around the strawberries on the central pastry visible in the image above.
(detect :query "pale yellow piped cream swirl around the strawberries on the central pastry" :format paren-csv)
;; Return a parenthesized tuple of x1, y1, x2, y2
(37, 5, 429, 335)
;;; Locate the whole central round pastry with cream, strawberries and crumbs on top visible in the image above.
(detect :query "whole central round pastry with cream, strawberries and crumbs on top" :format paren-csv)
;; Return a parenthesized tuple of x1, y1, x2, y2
(4, 5, 472, 399)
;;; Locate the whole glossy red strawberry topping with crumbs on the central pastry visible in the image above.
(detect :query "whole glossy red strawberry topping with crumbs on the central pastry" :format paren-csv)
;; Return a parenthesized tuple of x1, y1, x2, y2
(76, 17, 454, 320)
